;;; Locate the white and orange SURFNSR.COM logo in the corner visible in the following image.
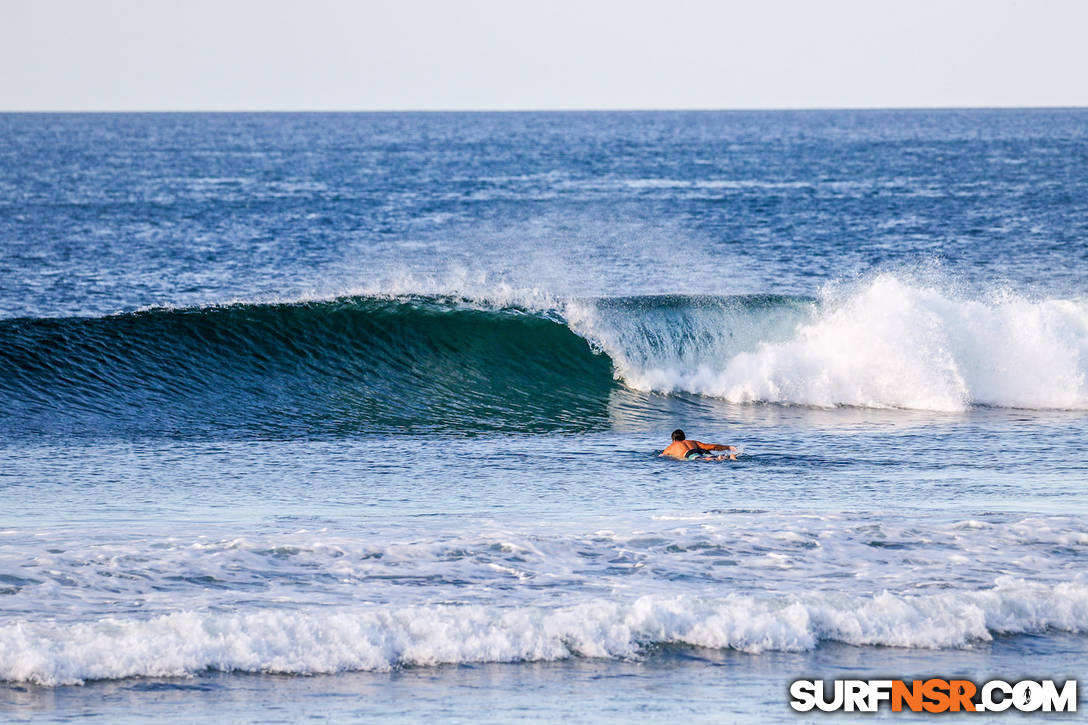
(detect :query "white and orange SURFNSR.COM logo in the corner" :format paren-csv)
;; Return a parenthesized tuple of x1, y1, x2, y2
(790, 677, 1077, 713)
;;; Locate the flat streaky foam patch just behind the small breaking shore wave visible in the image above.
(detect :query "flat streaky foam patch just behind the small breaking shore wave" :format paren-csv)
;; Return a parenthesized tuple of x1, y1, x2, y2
(8, 512, 1088, 624)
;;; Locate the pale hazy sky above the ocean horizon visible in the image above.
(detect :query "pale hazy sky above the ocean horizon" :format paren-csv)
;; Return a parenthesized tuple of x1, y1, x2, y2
(0, 0, 1088, 111)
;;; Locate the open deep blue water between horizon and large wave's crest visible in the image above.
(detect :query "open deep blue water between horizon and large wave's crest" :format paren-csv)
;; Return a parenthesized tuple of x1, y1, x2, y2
(6, 110, 1088, 316)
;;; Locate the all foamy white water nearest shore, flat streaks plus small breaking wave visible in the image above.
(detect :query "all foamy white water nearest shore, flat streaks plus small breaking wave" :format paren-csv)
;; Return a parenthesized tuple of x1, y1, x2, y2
(6, 513, 1088, 686)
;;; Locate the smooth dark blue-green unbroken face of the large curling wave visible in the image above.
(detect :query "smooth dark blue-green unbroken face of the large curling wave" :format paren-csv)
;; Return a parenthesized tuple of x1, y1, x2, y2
(0, 297, 614, 434)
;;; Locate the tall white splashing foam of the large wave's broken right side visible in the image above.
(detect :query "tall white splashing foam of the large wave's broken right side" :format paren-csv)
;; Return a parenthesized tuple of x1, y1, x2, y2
(572, 274, 1088, 411)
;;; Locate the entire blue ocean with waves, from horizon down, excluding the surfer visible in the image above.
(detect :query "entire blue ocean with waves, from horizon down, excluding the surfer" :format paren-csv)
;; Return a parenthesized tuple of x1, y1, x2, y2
(0, 109, 1088, 723)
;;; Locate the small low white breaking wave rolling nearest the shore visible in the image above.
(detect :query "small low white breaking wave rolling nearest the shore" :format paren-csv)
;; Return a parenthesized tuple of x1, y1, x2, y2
(0, 578, 1088, 686)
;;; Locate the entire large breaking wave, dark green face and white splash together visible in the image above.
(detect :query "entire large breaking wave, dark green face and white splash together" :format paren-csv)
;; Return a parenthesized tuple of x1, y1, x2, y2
(0, 274, 1088, 435)
